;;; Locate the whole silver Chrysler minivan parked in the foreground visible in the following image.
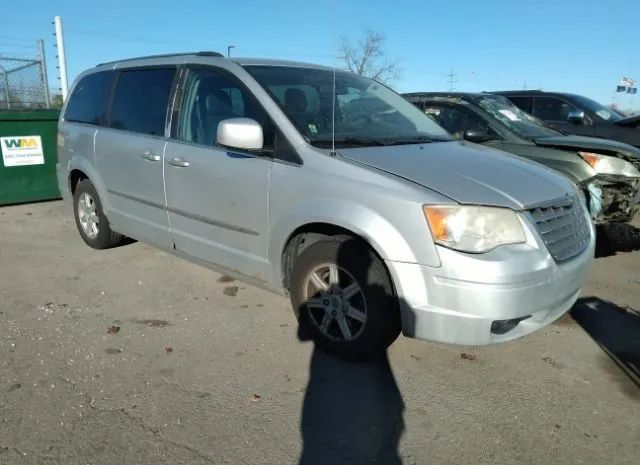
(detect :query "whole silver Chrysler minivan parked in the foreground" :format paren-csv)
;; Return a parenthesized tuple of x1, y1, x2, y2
(58, 52, 595, 360)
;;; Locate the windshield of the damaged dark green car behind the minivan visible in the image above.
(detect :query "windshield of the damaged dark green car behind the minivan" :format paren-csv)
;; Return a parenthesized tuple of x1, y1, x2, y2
(477, 95, 562, 139)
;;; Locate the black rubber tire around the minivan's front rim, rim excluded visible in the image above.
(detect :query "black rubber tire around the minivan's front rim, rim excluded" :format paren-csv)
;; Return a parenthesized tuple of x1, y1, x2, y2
(291, 238, 400, 361)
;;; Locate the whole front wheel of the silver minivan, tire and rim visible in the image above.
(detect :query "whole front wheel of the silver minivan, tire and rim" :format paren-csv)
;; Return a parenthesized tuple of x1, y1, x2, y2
(291, 237, 400, 361)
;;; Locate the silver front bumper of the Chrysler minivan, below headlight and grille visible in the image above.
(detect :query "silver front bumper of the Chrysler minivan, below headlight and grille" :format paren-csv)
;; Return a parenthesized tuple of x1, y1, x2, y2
(387, 214, 595, 345)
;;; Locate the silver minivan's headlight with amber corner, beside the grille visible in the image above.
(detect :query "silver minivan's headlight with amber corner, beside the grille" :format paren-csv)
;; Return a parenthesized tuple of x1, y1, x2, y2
(423, 205, 525, 253)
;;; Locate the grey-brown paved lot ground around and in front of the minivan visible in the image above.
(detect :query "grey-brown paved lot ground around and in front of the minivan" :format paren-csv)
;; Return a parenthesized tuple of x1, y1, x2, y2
(0, 202, 640, 465)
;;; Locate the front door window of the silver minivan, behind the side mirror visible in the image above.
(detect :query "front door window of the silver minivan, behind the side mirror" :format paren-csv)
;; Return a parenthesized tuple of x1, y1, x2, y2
(177, 69, 274, 150)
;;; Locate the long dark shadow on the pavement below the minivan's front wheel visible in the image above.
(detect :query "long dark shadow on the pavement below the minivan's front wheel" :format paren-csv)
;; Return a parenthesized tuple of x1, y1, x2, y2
(298, 239, 405, 465)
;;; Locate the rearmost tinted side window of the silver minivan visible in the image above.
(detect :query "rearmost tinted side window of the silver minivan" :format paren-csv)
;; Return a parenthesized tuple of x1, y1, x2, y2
(64, 71, 115, 124)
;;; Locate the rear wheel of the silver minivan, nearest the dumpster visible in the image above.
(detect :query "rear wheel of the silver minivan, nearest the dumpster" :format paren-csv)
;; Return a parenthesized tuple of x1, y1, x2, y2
(73, 179, 124, 250)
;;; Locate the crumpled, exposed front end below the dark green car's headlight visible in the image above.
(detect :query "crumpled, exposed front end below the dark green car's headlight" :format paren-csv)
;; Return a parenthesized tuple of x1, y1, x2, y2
(584, 174, 640, 224)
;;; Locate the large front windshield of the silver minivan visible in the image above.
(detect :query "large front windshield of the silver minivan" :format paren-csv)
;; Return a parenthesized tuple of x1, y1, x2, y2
(245, 65, 453, 148)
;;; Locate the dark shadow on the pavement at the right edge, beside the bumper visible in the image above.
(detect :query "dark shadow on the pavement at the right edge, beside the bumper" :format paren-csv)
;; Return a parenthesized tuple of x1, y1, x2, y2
(571, 297, 640, 396)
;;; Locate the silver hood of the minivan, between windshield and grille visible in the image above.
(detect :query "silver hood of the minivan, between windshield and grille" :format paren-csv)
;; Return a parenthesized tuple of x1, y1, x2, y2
(339, 142, 572, 210)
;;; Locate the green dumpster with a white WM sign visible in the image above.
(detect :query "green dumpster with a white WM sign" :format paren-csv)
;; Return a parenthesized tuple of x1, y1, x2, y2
(0, 110, 60, 205)
